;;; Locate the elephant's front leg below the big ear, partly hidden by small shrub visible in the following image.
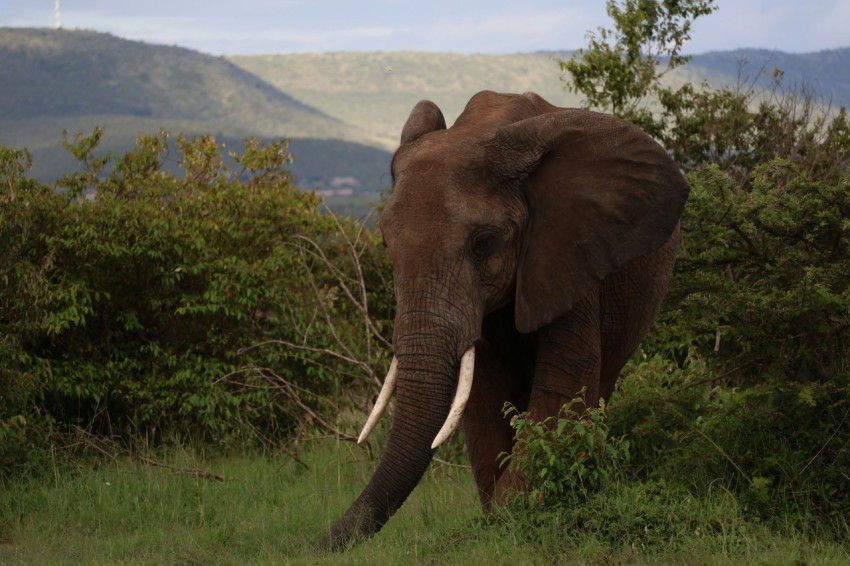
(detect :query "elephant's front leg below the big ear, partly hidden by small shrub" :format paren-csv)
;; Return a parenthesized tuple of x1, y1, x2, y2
(494, 290, 602, 501)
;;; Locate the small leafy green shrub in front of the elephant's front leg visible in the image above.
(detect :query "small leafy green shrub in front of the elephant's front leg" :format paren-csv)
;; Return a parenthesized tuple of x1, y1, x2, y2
(500, 399, 629, 512)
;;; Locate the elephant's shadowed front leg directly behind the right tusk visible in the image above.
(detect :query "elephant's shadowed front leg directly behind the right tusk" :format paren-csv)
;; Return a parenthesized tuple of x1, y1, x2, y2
(463, 307, 533, 511)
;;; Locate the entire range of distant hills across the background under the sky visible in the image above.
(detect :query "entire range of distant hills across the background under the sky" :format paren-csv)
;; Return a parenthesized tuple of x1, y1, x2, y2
(0, 28, 850, 205)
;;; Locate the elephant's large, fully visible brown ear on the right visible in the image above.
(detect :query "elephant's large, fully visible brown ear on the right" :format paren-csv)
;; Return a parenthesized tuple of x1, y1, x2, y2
(495, 109, 690, 332)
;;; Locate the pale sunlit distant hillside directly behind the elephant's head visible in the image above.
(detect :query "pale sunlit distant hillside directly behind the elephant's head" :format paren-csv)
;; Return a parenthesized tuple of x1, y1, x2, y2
(230, 52, 579, 149)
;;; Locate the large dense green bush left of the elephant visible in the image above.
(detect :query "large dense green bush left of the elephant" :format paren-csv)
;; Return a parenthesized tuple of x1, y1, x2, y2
(0, 130, 389, 480)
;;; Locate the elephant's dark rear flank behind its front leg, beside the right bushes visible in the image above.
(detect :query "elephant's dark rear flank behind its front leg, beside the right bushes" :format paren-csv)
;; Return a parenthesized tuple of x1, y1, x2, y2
(599, 226, 679, 400)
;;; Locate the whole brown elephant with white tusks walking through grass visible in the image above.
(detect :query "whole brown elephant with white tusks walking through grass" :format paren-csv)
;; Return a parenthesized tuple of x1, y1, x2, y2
(317, 91, 690, 550)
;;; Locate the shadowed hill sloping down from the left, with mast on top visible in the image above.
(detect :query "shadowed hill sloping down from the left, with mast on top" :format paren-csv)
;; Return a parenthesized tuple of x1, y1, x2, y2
(0, 28, 364, 139)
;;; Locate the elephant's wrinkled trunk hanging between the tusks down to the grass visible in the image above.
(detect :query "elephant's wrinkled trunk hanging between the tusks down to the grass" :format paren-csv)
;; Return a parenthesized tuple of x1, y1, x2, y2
(318, 325, 458, 551)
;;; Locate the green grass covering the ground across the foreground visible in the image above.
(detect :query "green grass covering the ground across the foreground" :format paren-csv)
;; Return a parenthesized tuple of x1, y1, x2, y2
(0, 440, 850, 565)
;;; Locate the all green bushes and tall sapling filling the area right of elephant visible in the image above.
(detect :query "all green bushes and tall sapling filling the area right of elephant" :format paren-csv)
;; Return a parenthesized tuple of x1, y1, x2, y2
(565, 2, 850, 536)
